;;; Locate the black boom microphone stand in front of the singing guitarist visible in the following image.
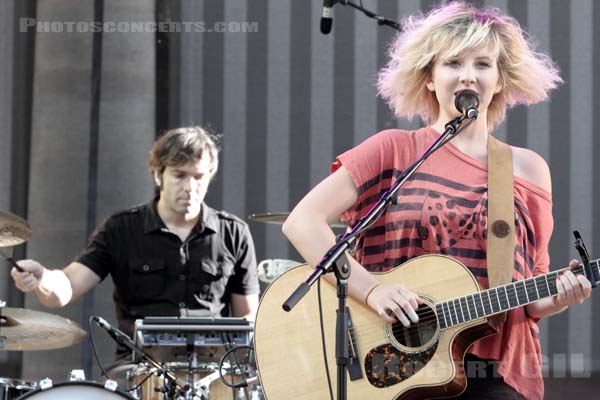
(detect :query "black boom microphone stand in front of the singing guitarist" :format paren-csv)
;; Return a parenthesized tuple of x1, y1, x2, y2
(282, 115, 475, 400)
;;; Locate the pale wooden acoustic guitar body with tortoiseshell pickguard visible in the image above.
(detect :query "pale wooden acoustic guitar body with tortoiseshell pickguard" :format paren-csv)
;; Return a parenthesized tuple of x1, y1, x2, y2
(254, 255, 496, 400)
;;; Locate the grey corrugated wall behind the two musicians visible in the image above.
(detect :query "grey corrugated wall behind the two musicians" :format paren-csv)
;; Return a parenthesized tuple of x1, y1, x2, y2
(0, 0, 600, 396)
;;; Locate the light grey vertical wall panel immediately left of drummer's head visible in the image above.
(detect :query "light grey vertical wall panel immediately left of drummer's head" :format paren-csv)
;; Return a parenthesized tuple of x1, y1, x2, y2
(88, 0, 156, 376)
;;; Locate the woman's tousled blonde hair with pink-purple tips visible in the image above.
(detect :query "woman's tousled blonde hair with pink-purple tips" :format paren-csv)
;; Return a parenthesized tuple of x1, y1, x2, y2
(377, 2, 562, 130)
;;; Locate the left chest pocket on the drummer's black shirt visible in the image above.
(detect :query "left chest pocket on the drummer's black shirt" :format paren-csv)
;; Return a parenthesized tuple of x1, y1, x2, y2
(130, 259, 167, 303)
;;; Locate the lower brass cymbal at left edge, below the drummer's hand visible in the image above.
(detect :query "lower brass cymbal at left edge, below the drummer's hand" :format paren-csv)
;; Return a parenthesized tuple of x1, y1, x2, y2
(0, 307, 87, 351)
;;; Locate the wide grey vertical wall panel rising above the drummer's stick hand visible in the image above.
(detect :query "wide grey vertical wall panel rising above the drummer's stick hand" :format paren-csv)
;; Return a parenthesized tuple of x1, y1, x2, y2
(23, 0, 93, 380)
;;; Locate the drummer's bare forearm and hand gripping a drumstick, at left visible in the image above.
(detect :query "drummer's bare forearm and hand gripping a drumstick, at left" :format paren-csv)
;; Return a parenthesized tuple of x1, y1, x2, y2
(10, 260, 101, 307)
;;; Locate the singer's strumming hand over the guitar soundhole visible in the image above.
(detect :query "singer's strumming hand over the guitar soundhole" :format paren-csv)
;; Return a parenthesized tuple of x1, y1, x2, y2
(367, 284, 423, 327)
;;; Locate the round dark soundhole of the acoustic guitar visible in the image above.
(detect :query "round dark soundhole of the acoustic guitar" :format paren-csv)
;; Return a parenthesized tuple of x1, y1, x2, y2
(390, 304, 437, 349)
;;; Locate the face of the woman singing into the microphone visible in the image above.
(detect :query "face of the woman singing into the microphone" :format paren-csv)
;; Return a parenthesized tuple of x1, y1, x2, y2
(427, 46, 500, 122)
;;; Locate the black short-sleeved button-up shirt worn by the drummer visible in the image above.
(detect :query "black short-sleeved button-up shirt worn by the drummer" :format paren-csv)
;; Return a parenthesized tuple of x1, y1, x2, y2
(75, 201, 259, 335)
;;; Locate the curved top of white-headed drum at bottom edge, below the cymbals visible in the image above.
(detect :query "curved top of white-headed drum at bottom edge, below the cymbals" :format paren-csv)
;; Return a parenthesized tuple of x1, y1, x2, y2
(18, 381, 135, 400)
